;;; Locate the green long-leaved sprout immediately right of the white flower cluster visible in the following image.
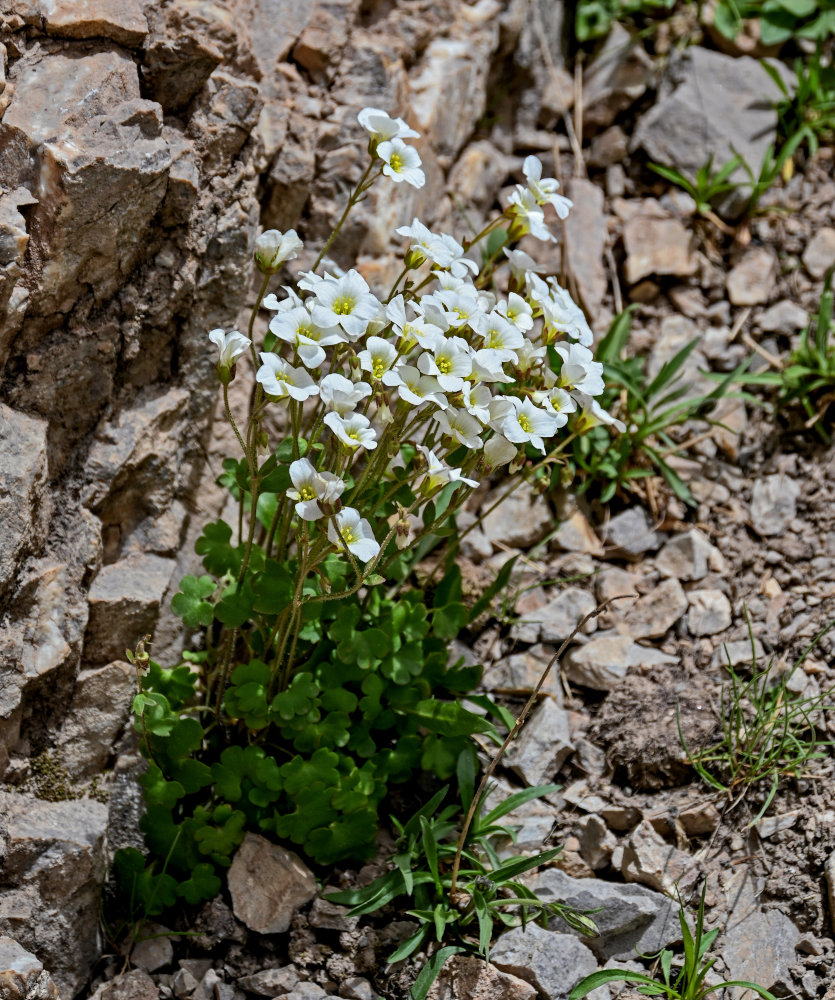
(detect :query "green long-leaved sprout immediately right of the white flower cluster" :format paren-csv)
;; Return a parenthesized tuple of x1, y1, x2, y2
(569, 306, 745, 505)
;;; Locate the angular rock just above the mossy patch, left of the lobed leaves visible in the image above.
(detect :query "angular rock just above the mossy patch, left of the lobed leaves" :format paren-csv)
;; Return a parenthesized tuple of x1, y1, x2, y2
(58, 662, 136, 780)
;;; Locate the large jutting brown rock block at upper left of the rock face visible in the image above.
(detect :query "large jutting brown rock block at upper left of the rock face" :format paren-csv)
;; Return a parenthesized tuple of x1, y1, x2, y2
(0, 49, 171, 316)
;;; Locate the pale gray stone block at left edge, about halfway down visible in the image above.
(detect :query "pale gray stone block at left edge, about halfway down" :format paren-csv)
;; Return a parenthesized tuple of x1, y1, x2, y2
(0, 403, 50, 600)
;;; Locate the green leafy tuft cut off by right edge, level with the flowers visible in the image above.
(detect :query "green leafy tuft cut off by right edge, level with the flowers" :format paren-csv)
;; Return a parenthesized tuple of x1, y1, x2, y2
(740, 268, 835, 444)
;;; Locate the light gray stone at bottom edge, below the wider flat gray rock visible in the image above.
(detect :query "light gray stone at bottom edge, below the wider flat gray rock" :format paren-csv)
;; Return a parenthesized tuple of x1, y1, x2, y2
(490, 923, 608, 1000)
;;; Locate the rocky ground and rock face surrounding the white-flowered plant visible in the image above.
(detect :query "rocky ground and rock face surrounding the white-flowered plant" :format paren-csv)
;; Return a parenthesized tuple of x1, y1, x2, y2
(0, 0, 835, 1000)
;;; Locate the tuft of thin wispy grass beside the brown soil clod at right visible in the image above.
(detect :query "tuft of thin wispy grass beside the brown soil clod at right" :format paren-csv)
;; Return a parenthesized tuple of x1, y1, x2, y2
(679, 620, 835, 826)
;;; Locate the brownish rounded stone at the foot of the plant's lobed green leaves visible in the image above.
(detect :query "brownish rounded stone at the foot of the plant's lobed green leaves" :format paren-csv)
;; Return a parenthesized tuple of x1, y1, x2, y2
(228, 833, 316, 934)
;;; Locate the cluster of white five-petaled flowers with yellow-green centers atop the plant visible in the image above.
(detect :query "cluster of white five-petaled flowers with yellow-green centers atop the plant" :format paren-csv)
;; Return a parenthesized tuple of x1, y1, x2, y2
(210, 108, 615, 565)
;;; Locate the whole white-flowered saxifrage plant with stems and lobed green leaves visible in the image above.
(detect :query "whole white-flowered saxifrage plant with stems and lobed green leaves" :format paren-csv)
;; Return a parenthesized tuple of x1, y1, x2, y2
(114, 108, 624, 915)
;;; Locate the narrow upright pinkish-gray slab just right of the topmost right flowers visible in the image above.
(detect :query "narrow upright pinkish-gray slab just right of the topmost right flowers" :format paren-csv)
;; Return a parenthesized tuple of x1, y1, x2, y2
(563, 177, 608, 323)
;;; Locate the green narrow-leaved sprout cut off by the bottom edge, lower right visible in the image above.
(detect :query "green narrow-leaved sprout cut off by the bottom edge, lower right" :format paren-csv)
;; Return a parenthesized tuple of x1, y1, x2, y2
(568, 882, 776, 1000)
